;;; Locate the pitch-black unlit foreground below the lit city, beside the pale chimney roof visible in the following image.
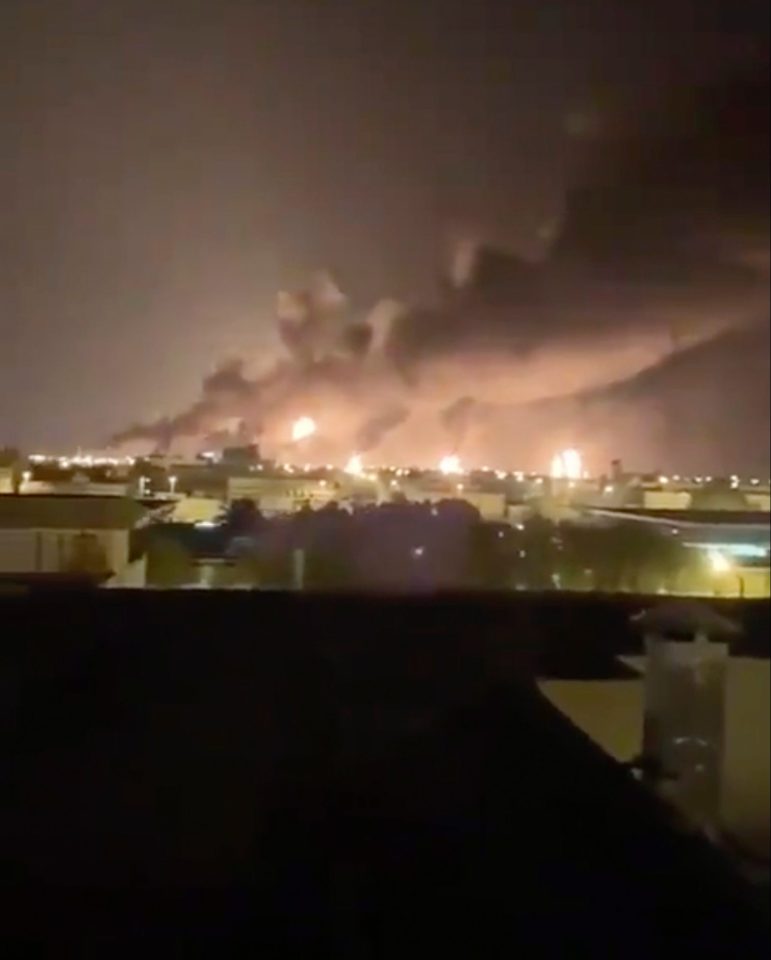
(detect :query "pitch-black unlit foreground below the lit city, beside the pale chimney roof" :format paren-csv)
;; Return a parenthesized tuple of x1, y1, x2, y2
(0, 591, 768, 958)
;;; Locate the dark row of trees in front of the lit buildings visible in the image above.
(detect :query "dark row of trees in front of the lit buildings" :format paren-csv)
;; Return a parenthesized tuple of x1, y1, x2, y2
(143, 500, 703, 593)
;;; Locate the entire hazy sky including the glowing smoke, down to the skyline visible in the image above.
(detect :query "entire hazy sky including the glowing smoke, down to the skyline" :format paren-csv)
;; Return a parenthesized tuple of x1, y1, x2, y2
(0, 0, 769, 473)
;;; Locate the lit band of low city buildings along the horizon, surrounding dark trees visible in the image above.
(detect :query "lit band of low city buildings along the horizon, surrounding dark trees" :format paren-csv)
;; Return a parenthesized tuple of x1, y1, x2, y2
(0, 446, 771, 598)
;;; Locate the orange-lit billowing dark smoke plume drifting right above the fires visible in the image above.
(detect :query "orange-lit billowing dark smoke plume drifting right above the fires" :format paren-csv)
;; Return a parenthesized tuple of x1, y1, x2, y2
(110, 65, 769, 474)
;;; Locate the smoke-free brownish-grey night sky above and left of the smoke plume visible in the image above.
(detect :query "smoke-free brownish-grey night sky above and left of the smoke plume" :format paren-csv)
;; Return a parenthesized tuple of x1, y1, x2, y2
(0, 0, 768, 466)
